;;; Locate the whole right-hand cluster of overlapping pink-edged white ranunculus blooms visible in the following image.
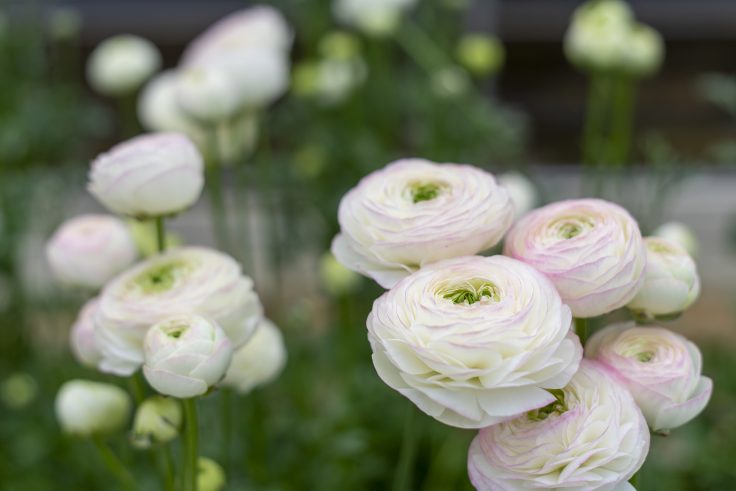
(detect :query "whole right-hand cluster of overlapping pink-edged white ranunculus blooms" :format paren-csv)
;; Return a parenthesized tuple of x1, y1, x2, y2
(333, 160, 712, 491)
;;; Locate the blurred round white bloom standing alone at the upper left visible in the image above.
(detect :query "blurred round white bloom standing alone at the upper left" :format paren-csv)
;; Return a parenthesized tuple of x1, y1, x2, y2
(87, 34, 161, 96)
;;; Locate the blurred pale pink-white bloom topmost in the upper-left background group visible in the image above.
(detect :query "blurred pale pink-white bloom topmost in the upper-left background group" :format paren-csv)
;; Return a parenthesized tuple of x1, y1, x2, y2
(182, 5, 294, 65)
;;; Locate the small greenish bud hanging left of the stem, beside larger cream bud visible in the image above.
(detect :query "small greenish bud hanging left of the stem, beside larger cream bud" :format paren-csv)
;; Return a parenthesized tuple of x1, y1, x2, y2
(131, 396, 182, 448)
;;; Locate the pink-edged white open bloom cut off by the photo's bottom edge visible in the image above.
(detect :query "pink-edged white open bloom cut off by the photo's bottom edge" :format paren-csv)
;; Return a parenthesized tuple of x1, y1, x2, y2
(468, 360, 649, 491)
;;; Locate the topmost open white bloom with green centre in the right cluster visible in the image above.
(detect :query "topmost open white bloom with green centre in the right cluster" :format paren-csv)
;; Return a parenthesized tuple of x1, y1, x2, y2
(332, 159, 514, 288)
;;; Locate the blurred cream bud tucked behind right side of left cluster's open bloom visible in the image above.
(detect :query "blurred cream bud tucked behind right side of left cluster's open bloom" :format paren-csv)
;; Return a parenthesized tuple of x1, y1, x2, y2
(222, 319, 286, 394)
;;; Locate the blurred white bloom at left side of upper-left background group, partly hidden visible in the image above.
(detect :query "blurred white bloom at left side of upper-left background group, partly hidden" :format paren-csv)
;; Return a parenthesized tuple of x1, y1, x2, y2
(138, 70, 207, 149)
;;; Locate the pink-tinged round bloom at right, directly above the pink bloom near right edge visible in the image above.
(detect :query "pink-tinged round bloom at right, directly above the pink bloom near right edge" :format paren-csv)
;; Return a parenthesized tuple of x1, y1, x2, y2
(504, 199, 646, 317)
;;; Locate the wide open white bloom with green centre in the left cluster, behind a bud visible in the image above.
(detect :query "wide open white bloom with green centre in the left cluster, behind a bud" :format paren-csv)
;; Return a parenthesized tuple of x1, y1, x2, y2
(95, 247, 262, 375)
